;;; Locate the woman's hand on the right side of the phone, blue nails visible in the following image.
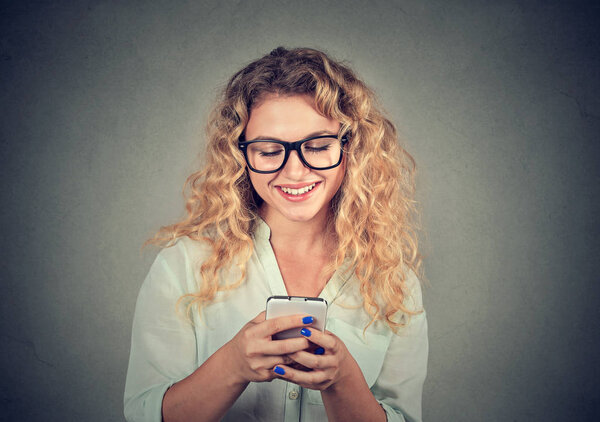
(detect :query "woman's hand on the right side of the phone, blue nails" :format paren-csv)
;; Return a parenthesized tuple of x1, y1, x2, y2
(274, 327, 360, 391)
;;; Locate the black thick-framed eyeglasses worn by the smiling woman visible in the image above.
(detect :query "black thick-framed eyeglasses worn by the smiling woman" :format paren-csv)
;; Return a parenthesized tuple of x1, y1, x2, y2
(238, 135, 348, 173)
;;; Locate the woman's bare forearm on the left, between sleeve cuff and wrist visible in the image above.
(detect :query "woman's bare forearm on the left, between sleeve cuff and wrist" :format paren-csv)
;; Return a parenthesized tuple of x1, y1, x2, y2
(162, 344, 248, 422)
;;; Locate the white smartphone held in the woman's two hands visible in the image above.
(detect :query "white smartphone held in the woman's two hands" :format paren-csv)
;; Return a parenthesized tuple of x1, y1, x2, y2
(266, 296, 327, 340)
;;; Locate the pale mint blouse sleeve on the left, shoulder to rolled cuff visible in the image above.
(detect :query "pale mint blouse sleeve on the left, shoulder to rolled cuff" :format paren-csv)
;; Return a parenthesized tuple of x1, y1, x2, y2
(124, 245, 197, 422)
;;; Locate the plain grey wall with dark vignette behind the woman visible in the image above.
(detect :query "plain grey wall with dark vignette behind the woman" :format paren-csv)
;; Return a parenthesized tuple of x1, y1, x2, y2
(0, 0, 600, 421)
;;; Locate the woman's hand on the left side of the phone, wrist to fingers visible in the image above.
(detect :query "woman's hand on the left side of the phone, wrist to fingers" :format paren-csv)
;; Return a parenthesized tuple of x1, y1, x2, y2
(226, 311, 312, 384)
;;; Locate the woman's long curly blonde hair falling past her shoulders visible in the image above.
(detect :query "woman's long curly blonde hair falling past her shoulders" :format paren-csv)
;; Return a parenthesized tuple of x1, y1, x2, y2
(144, 47, 421, 330)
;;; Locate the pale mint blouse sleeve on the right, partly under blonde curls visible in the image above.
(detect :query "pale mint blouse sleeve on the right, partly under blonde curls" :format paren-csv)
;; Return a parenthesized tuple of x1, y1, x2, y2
(371, 273, 429, 422)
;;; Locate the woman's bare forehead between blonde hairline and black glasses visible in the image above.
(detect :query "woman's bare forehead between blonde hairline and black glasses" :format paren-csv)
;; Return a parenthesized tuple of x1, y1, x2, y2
(245, 94, 340, 142)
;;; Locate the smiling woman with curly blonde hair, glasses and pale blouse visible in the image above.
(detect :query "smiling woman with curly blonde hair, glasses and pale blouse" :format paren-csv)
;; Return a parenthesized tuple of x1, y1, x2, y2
(125, 47, 428, 422)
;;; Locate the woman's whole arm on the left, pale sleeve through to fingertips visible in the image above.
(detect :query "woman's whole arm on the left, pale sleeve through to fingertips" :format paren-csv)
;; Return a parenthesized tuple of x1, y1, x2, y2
(124, 251, 310, 422)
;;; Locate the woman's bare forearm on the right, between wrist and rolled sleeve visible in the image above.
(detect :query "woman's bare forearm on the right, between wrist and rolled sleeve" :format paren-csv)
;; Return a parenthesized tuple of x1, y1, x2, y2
(321, 362, 387, 422)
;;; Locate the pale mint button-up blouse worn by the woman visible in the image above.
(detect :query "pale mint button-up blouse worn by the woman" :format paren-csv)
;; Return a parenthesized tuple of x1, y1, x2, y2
(125, 220, 428, 422)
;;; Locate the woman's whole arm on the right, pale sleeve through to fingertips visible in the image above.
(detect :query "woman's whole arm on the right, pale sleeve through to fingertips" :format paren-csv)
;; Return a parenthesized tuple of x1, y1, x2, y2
(274, 273, 428, 422)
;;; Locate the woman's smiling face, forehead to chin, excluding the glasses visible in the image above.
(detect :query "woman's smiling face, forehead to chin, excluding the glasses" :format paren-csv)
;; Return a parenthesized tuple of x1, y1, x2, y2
(245, 94, 346, 222)
